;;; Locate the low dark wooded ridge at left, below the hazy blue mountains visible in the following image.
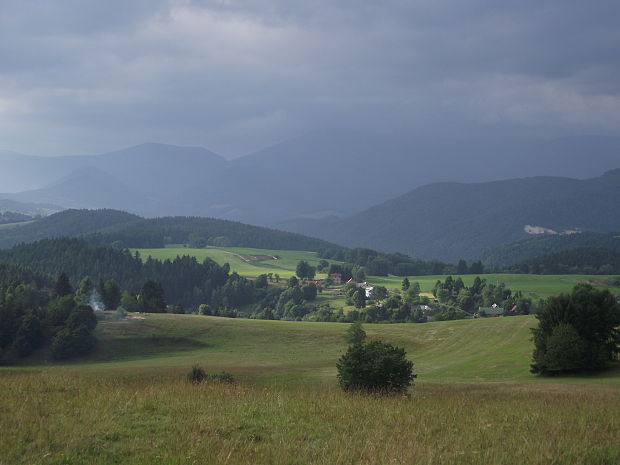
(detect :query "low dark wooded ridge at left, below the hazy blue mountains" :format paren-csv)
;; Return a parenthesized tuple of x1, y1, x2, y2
(0, 210, 343, 251)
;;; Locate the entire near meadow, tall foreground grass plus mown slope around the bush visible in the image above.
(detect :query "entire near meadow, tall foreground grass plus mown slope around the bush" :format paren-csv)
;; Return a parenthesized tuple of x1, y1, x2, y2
(0, 315, 620, 465)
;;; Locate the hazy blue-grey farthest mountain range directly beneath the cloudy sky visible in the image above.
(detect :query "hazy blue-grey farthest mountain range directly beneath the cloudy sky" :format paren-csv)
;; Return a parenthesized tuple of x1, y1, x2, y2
(0, 131, 620, 225)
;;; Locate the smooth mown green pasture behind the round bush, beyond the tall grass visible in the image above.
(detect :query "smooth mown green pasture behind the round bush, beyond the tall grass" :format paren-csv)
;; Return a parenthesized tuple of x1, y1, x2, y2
(9, 314, 620, 386)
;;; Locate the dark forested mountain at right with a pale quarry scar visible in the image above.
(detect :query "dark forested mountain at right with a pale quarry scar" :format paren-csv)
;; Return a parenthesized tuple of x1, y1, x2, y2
(282, 169, 620, 264)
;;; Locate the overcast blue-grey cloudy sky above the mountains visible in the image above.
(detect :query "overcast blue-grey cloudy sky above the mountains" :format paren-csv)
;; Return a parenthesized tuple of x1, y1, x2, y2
(0, 0, 620, 157)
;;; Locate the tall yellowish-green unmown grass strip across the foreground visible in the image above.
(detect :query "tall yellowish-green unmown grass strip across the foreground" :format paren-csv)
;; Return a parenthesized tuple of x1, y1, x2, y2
(0, 371, 620, 465)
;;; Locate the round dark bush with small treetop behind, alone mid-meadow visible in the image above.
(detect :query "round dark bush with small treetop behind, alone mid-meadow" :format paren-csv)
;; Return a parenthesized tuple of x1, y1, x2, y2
(336, 324, 416, 392)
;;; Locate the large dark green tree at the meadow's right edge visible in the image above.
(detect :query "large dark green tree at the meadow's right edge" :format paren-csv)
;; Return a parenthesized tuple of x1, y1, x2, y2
(531, 284, 620, 375)
